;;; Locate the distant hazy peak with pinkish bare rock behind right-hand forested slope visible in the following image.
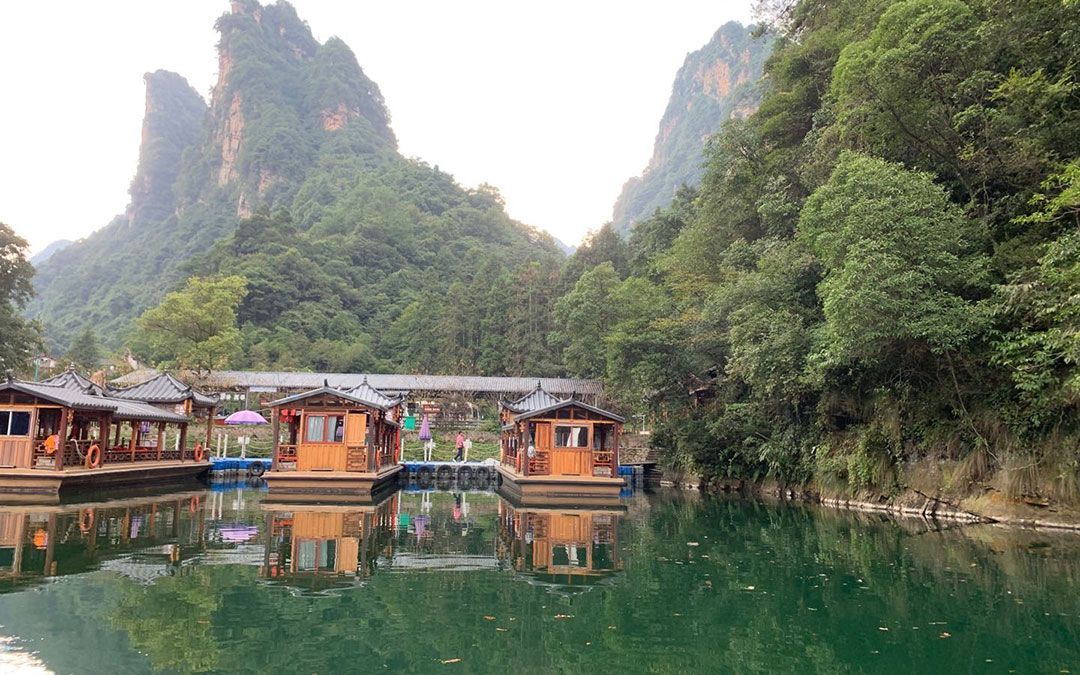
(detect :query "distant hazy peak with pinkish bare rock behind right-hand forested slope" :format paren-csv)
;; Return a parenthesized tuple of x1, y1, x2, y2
(612, 22, 772, 233)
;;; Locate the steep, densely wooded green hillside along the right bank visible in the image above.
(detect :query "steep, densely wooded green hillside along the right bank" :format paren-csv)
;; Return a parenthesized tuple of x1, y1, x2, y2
(555, 0, 1080, 501)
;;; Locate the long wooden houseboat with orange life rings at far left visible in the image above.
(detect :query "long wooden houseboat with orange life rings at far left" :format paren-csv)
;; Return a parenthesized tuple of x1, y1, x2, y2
(0, 369, 214, 501)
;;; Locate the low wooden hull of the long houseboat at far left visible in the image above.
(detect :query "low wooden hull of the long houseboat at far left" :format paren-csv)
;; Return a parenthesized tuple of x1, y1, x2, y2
(0, 460, 210, 503)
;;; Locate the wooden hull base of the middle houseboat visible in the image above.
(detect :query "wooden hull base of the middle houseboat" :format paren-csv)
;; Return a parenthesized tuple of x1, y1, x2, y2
(262, 464, 402, 503)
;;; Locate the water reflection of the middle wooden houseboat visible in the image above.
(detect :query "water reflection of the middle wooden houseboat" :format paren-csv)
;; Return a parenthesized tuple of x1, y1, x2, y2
(259, 499, 396, 592)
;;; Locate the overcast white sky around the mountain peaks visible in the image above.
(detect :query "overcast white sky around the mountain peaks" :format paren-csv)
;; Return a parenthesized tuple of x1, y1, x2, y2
(0, 0, 750, 251)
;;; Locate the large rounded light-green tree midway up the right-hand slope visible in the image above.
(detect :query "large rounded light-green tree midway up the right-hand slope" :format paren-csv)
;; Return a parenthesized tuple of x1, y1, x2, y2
(799, 153, 988, 364)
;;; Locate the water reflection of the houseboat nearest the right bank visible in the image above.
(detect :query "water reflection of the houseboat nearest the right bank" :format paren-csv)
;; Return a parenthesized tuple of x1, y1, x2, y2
(497, 502, 622, 586)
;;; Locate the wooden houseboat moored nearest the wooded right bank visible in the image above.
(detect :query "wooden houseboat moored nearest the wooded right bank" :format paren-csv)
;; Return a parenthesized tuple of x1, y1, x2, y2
(498, 382, 625, 504)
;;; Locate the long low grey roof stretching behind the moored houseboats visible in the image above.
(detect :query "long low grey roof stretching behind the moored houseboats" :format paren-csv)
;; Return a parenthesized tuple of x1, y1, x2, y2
(111, 368, 604, 396)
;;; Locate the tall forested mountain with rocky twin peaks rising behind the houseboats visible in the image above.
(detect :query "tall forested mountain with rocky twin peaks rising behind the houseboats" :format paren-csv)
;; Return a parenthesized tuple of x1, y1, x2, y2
(29, 0, 564, 372)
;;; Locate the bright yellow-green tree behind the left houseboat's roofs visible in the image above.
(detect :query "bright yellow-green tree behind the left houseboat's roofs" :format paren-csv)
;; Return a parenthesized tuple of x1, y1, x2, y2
(132, 276, 247, 373)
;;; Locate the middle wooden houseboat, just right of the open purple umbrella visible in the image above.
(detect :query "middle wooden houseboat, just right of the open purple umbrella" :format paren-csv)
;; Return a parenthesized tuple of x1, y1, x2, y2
(264, 379, 402, 501)
